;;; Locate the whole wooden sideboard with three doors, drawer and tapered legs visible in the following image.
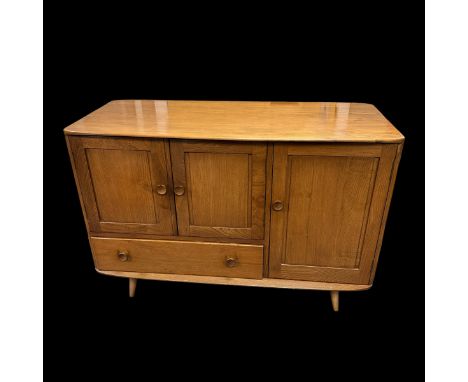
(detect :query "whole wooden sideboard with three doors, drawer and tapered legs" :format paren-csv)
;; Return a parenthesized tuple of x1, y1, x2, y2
(64, 100, 404, 311)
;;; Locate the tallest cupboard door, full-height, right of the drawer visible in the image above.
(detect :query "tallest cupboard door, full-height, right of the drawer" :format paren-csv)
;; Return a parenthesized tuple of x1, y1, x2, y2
(269, 144, 397, 284)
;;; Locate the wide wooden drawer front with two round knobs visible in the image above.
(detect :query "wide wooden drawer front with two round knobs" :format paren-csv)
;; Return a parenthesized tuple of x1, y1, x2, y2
(90, 237, 263, 279)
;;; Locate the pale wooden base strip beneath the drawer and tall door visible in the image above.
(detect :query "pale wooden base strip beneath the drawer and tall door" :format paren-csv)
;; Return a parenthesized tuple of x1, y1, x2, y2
(96, 268, 372, 292)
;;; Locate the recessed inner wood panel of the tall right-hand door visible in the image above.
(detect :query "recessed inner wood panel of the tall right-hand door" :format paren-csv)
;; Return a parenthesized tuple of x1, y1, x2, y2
(282, 155, 378, 268)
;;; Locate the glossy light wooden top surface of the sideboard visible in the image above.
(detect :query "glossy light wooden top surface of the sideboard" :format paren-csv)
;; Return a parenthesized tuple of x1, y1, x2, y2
(65, 100, 404, 143)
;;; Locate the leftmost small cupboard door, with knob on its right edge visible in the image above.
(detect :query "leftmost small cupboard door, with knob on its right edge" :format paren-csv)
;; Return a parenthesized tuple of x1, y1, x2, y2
(68, 136, 176, 235)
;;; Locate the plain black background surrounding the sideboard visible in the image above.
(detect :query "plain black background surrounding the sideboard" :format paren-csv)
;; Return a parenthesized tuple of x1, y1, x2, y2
(44, 1, 424, 380)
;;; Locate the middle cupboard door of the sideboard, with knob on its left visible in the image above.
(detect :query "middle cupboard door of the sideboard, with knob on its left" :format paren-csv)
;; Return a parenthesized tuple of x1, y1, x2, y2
(170, 140, 266, 239)
